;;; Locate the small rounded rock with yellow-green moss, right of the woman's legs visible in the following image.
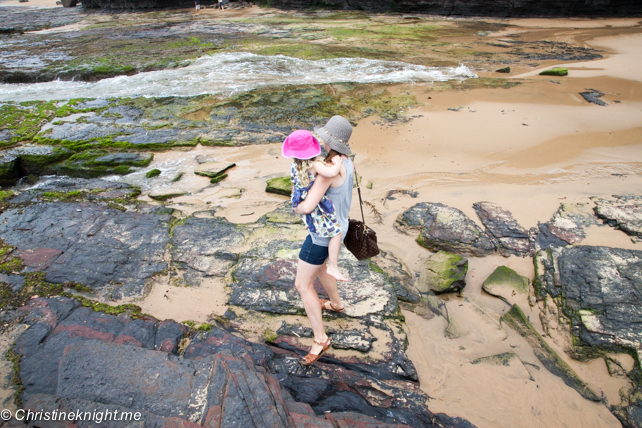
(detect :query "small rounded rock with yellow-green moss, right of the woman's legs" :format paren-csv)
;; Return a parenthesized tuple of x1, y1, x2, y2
(417, 251, 468, 294)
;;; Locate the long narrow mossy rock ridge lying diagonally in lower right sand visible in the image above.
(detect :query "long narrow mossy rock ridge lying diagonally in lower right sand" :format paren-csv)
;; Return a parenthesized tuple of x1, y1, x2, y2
(502, 305, 600, 401)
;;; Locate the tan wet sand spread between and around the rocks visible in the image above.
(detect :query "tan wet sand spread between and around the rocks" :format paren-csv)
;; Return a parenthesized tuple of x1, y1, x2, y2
(119, 16, 642, 428)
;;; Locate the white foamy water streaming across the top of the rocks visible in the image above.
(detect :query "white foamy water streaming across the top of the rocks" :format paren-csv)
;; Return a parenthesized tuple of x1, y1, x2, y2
(0, 53, 470, 101)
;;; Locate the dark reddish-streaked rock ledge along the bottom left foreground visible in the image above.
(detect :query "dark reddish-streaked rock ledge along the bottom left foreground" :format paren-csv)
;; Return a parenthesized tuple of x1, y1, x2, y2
(7, 297, 472, 428)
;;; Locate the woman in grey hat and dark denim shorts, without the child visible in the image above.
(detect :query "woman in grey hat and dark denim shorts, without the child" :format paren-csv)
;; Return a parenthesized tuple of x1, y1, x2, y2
(294, 116, 354, 365)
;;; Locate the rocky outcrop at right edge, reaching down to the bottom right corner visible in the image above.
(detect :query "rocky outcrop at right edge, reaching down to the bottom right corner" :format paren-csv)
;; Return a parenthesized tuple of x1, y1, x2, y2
(535, 246, 642, 427)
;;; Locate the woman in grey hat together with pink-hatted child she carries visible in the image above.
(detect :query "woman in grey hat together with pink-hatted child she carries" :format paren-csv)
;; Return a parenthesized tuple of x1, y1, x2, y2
(283, 116, 354, 365)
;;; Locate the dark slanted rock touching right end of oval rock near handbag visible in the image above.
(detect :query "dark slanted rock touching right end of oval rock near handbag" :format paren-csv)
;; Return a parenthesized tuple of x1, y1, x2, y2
(473, 202, 531, 257)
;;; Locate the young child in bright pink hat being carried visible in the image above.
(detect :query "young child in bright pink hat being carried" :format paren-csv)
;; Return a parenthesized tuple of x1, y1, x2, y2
(283, 130, 348, 281)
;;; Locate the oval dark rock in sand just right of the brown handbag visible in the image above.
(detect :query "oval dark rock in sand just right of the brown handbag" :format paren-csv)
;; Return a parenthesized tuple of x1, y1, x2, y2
(396, 202, 496, 257)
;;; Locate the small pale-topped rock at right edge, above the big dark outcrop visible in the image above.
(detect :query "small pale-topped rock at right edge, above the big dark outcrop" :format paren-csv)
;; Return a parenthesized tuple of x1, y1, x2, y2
(593, 196, 642, 242)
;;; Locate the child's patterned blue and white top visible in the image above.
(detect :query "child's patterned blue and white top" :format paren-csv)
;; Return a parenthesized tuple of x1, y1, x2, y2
(290, 162, 341, 238)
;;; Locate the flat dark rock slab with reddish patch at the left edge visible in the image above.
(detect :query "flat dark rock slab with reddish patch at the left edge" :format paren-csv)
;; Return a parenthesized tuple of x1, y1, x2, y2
(0, 203, 170, 299)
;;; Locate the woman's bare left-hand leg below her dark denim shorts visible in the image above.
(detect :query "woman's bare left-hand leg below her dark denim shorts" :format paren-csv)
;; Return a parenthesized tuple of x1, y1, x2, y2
(294, 260, 328, 354)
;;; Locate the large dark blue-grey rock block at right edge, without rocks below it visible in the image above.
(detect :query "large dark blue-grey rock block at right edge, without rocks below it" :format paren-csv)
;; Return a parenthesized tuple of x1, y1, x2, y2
(536, 246, 642, 362)
